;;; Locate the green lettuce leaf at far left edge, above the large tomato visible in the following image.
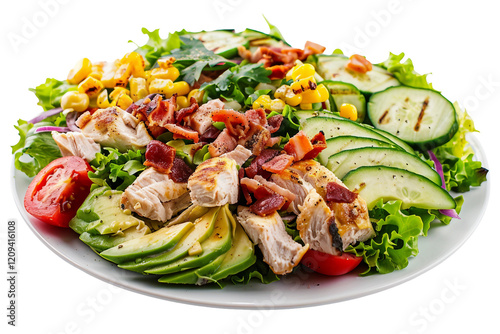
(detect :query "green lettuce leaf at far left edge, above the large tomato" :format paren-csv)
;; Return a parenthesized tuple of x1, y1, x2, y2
(12, 119, 62, 177)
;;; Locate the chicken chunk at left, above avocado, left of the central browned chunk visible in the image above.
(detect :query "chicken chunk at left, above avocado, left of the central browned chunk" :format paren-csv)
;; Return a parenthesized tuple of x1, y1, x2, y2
(121, 167, 191, 222)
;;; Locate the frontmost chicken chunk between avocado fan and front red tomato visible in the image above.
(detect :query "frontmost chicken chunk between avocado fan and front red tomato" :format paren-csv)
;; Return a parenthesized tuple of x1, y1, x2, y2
(237, 206, 309, 275)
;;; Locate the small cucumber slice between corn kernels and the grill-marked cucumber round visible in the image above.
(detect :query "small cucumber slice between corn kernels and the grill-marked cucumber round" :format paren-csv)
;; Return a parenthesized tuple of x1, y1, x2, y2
(318, 80, 366, 123)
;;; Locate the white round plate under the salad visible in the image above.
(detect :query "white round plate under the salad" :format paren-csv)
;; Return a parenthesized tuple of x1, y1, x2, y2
(12, 137, 490, 308)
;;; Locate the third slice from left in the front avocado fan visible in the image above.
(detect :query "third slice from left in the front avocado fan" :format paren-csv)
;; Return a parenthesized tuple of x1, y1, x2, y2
(145, 208, 232, 275)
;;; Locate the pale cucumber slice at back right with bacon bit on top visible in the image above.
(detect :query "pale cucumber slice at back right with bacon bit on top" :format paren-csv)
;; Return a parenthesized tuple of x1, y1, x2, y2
(315, 55, 400, 95)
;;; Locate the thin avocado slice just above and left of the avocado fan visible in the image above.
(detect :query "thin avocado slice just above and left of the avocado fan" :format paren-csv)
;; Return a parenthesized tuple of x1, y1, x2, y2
(80, 225, 150, 255)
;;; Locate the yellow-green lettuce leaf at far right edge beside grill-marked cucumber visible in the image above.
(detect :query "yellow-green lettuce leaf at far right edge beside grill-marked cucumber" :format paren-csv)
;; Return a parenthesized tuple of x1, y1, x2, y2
(433, 103, 488, 192)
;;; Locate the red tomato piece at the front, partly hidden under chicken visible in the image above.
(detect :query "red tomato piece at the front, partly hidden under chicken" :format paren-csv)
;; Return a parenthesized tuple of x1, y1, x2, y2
(301, 249, 363, 276)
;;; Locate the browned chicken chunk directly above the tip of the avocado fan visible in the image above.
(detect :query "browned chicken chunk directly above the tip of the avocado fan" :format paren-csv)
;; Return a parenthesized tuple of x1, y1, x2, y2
(187, 157, 239, 207)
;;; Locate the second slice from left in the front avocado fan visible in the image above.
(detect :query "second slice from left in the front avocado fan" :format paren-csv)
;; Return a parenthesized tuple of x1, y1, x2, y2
(118, 207, 220, 273)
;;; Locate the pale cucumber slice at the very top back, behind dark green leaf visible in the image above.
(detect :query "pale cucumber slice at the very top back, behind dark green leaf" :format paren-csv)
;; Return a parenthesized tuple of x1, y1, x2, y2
(190, 30, 249, 59)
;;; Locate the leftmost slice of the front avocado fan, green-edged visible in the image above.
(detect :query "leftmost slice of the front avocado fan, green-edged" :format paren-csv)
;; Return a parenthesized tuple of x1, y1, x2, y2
(100, 222, 194, 263)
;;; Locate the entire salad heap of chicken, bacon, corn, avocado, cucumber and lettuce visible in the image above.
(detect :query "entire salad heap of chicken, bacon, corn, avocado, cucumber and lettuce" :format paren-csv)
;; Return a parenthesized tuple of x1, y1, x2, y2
(12, 24, 488, 286)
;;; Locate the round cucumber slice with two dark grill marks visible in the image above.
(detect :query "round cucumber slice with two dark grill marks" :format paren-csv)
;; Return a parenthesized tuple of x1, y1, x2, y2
(368, 86, 458, 150)
